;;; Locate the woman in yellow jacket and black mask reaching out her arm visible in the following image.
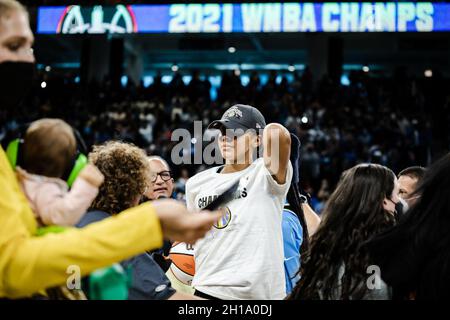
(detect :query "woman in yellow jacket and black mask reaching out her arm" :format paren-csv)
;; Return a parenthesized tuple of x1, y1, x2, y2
(0, 0, 220, 298)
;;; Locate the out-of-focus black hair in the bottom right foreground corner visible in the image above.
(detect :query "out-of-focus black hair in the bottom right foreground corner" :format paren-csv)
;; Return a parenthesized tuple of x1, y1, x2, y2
(368, 153, 450, 299)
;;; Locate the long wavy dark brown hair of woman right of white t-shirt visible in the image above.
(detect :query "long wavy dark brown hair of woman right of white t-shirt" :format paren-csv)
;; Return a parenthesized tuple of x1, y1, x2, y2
(289, 164, 395, 299)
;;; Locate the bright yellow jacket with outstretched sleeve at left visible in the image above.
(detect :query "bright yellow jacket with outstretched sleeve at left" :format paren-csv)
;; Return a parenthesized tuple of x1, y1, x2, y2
(0, 147, 162, 298)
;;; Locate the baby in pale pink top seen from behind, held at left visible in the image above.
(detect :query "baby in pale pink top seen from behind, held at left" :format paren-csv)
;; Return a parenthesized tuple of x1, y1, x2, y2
(16, 119, 104, 226)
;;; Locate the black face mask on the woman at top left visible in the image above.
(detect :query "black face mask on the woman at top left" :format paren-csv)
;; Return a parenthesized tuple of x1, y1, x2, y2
(0, 61, 35, 109)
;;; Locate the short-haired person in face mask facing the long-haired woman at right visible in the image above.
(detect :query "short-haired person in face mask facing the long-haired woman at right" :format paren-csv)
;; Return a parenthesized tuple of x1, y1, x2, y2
(398, 166, 426, 213)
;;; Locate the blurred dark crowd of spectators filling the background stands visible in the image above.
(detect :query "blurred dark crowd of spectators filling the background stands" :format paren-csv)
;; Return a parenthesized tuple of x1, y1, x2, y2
(0, 64, 450, 211)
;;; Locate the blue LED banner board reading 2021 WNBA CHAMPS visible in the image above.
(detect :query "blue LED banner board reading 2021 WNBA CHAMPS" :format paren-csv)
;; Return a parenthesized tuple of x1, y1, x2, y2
(37, 2, 450, 34)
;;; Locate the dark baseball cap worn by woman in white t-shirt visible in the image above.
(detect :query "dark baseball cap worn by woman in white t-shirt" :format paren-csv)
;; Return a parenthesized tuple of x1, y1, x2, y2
(208, 104, 266, 134)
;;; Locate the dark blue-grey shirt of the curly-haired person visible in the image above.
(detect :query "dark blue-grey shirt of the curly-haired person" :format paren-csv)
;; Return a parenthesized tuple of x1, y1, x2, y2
(77, 211, 176, 300)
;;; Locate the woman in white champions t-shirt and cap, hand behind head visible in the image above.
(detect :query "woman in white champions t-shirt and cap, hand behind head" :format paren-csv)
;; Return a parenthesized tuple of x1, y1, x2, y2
(186, 105, 292, 299)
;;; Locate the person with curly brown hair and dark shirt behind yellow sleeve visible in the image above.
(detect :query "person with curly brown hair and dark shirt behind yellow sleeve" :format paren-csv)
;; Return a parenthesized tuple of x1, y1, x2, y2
(79, 141, 202, 300)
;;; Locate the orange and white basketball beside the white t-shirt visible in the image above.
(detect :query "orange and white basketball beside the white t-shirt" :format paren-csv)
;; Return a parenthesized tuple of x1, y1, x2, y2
(169, 242, 195, 285)
